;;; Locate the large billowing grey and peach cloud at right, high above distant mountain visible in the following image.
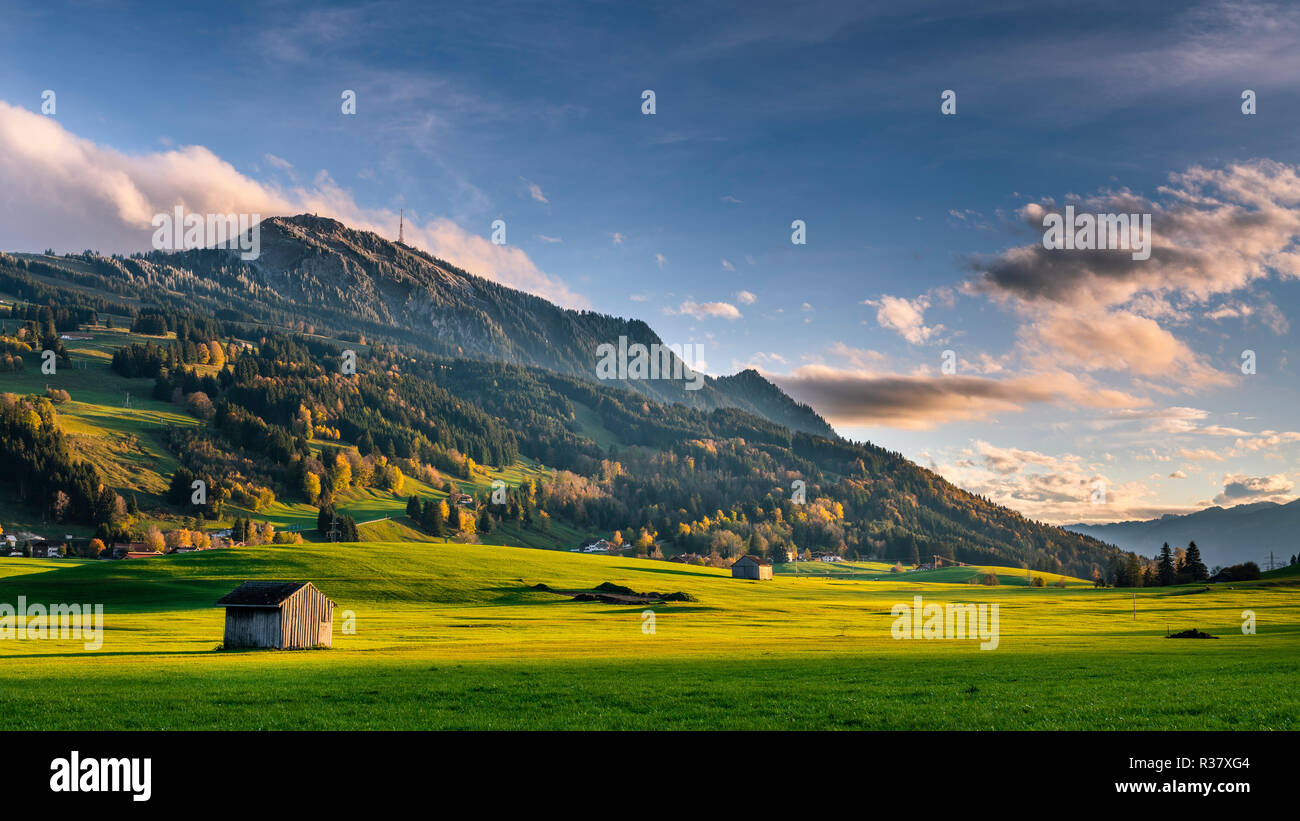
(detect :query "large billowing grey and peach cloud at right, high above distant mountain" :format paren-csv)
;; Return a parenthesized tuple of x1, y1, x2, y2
(956, 160, 1300, 394)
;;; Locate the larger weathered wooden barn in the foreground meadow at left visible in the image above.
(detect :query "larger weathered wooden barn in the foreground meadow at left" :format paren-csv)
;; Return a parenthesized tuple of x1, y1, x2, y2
(217, 582, 334, 650)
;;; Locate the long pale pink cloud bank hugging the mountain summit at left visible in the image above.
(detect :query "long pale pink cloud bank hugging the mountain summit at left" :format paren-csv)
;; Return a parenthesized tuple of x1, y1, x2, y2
(0, 101, 588, 308)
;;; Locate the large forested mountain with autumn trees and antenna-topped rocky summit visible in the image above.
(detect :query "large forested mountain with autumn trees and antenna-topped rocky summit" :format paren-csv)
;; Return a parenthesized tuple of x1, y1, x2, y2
(0, 216, 1123, 577)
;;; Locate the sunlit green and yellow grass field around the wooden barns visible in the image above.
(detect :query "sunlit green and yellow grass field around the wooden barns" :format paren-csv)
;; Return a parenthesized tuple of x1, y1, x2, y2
(0, 543, 1300, 730)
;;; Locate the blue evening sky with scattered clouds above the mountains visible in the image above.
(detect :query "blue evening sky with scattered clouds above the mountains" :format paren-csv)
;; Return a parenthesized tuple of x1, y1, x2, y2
(0, 0, 1300, 524)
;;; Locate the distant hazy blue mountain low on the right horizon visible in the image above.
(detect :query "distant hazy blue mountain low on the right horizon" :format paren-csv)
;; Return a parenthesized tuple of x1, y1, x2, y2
(1065, 499, 1300, 568)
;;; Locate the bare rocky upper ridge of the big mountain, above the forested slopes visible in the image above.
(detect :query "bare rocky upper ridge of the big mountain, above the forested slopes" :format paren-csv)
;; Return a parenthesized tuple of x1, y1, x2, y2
(165, 214, 835, 436)
